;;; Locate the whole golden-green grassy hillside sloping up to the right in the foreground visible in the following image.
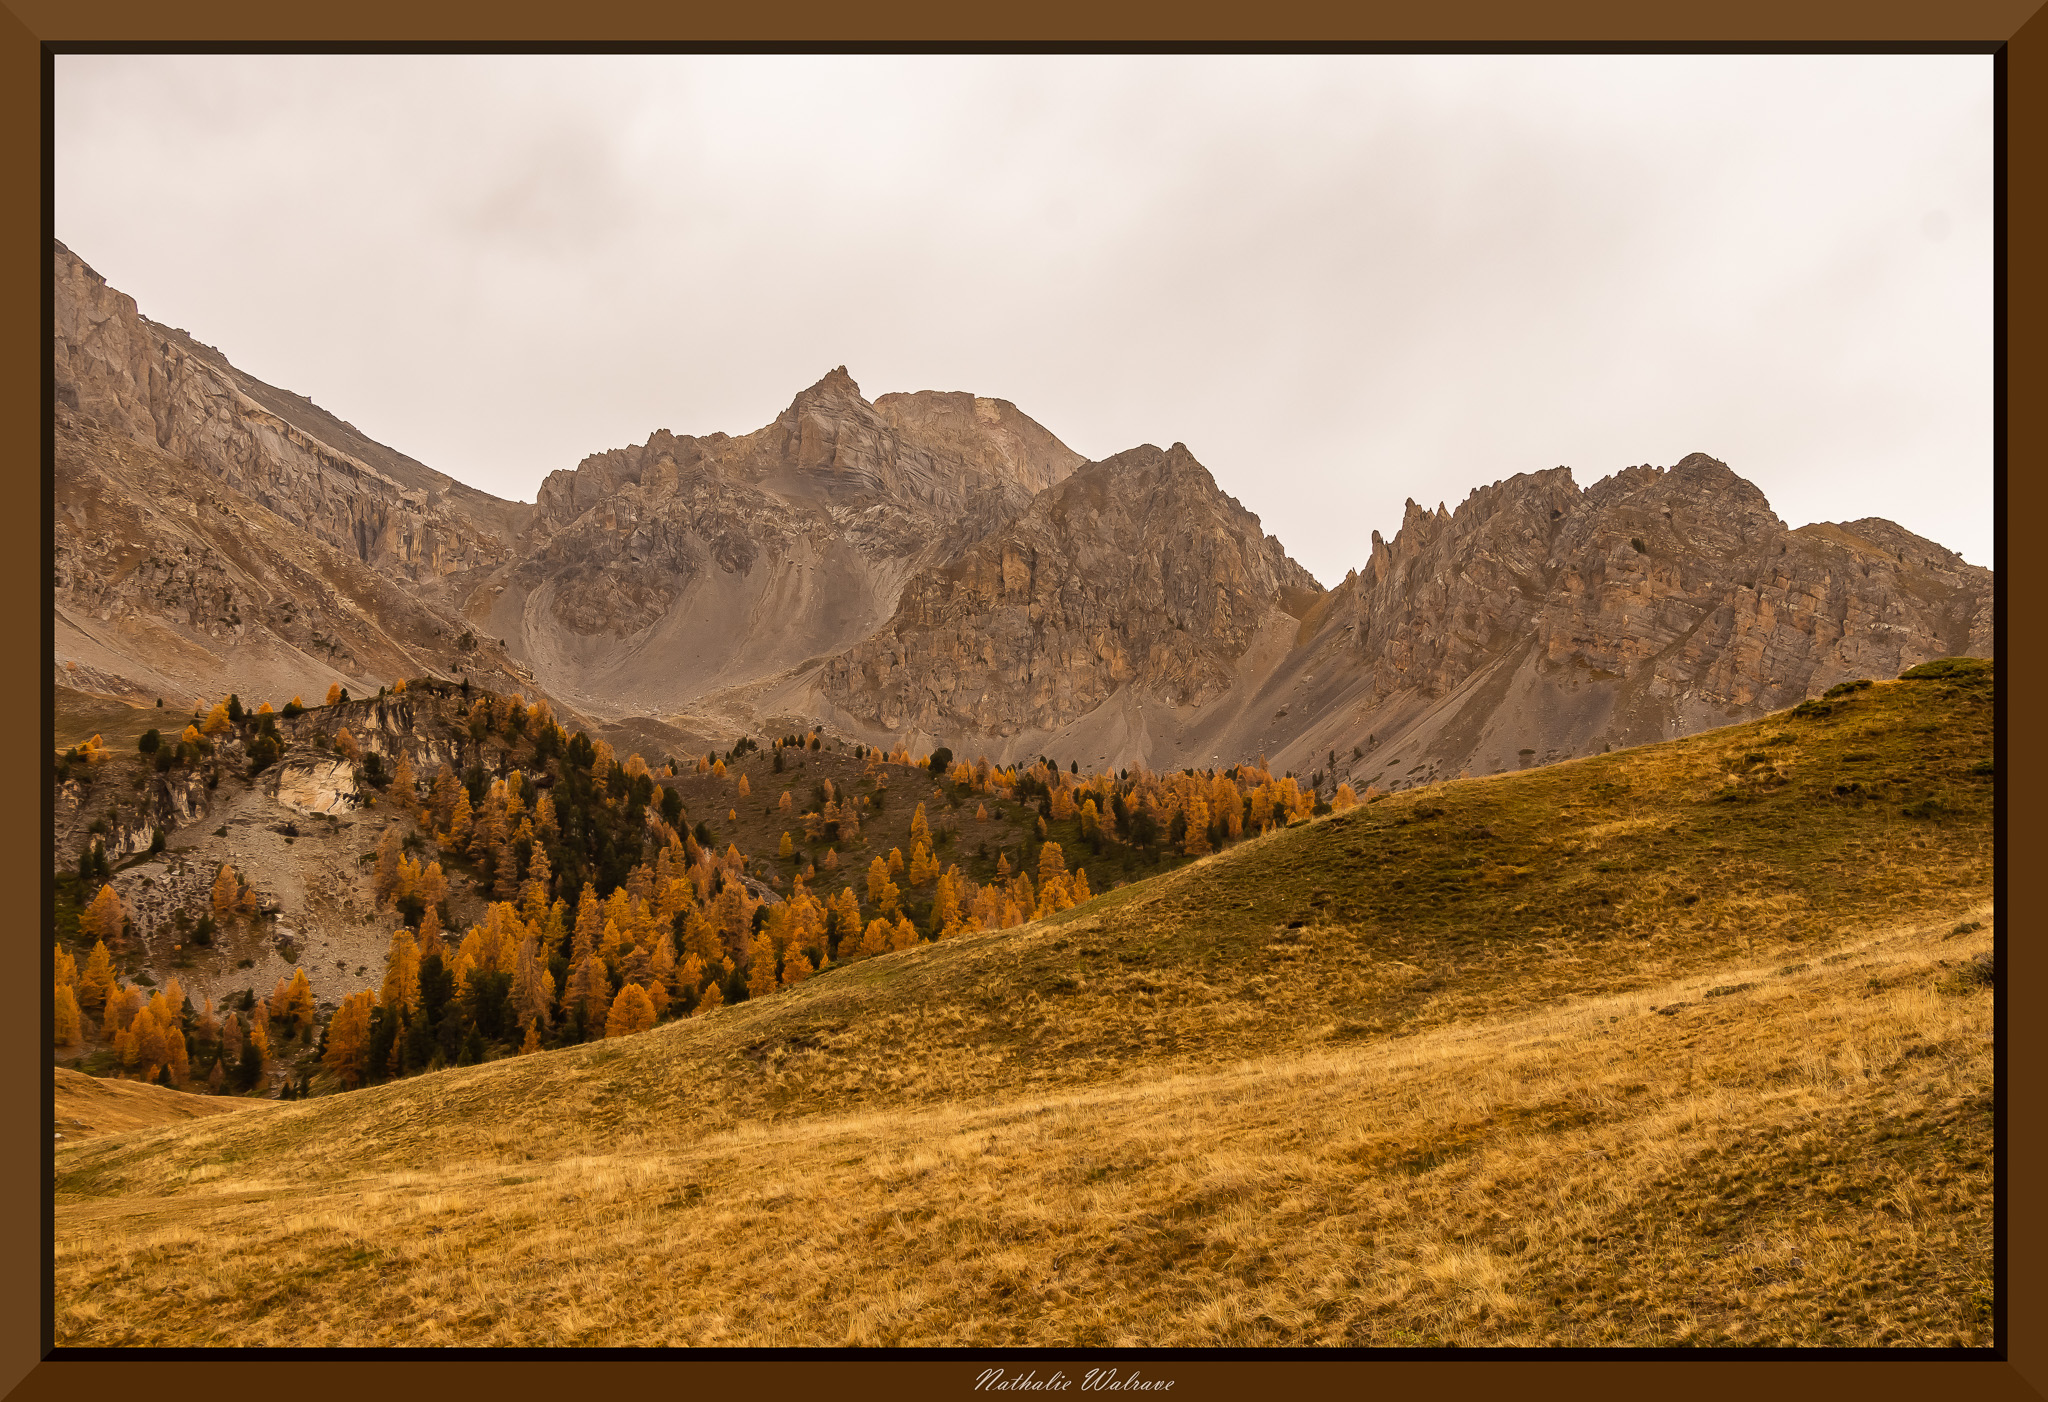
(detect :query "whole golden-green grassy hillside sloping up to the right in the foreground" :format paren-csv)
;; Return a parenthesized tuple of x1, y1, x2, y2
(55, 665, 1993, 1345)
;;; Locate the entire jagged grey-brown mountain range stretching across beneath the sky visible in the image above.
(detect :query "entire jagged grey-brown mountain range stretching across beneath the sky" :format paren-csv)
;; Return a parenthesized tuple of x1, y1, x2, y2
(55, 244, 1991, 786)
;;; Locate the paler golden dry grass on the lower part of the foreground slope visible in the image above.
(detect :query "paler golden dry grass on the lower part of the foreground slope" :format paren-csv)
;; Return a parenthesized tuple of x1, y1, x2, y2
(57, 908, 1991, 1347)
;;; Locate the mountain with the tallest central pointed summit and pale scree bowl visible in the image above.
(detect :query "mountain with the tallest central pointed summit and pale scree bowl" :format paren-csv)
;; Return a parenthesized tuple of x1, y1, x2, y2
(469, 366, 1083, 712)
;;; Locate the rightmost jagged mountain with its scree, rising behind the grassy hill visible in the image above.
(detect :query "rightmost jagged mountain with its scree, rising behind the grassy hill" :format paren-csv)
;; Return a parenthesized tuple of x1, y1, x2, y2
(1305, 452, 1993, 784)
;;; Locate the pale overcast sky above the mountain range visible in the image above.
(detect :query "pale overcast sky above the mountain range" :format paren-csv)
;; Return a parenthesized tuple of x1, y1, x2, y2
(55, 55, 1993, 585)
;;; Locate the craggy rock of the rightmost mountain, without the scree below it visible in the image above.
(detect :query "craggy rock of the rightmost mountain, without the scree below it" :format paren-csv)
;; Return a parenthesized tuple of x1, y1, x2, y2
(1352, 452, 1991, 710)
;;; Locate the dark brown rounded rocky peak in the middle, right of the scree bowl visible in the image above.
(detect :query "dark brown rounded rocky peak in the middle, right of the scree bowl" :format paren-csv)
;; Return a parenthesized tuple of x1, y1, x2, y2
(823, 444, 1321, 735)
